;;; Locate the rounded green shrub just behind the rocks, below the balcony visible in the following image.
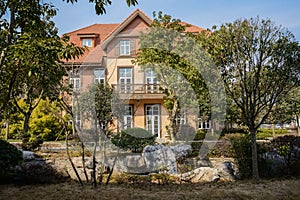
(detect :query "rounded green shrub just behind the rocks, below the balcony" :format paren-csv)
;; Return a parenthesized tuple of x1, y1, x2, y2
(111, 128, 156, 153)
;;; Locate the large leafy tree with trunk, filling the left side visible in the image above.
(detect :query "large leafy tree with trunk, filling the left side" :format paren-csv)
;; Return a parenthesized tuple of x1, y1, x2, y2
(0, 0, 84, 147)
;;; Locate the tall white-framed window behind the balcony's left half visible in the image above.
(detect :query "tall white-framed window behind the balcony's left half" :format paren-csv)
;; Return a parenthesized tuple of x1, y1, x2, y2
(119, 67, 132, 92)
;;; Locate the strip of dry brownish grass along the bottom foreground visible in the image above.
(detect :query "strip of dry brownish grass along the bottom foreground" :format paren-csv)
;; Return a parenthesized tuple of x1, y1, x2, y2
(0, 179, 300, 200)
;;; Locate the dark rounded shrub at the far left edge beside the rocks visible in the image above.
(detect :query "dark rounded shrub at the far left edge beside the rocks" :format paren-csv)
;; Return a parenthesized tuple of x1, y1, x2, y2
(0, 139, 23, 178)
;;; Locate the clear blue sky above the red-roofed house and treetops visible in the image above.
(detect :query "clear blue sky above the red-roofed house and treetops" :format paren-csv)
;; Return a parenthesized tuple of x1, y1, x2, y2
(50, 0, 300, 41)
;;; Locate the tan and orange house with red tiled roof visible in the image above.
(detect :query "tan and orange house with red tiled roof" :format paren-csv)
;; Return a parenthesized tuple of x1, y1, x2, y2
(65, 9, 209, 141)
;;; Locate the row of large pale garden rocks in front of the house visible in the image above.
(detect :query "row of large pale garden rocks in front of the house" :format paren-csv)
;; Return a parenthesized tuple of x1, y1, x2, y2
(20, 144, 239, 182)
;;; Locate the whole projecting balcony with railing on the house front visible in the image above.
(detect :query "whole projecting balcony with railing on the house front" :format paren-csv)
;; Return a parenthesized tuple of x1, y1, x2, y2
(112, 84, 164, 99)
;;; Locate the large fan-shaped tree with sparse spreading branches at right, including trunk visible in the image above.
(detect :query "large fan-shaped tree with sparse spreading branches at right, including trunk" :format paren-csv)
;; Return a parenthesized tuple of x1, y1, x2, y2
(202, 18, 300, 180)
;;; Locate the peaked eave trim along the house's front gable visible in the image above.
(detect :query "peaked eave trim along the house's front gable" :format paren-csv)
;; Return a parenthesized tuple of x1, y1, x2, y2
(101, 9, 152, 49)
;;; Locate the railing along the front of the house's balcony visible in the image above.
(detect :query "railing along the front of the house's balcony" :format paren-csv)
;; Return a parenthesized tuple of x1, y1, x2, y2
(112, 84, 162, 94)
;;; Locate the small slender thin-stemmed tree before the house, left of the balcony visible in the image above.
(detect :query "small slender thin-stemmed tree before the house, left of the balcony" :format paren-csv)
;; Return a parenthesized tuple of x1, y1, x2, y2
(77, 84, 115, 187)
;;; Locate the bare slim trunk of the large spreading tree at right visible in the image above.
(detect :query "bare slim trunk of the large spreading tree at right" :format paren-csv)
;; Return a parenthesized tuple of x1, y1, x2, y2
(250, 129, 259, 182)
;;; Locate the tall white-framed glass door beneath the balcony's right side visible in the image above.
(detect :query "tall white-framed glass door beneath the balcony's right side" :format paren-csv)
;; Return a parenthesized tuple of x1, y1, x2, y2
(145, 105, 160, 137)
